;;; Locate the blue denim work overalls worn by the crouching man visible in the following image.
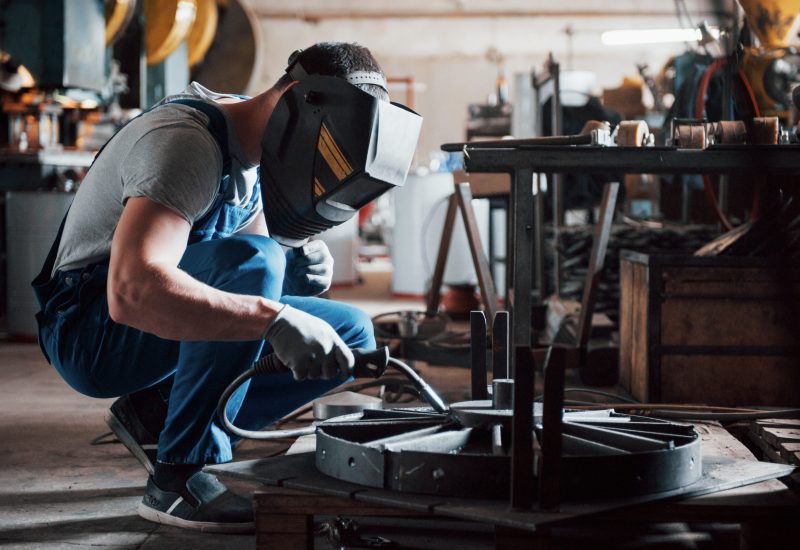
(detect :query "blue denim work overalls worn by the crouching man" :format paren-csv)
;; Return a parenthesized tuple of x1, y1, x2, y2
(33, 100, 375, 464)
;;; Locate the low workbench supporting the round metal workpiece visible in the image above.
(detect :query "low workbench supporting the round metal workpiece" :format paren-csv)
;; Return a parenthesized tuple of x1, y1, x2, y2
(207, 423, 800, 550)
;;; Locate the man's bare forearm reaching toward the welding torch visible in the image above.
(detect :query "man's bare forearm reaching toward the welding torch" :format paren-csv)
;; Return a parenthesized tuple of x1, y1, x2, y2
(108, 263, 281, 341)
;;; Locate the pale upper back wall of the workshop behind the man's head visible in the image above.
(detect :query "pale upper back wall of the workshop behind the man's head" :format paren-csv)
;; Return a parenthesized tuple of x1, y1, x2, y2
(247, 0, 730, 163)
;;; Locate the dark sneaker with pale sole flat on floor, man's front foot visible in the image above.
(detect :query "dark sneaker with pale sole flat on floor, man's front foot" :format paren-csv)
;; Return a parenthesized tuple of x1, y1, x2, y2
(139, 471, 255, 533)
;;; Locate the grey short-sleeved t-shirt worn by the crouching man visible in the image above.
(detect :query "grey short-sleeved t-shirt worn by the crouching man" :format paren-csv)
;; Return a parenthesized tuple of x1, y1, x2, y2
(53, 82, 261, 272)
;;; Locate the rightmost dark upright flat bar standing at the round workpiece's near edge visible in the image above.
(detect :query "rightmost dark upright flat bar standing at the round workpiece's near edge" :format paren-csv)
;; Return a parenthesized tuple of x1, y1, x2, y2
(536, 346, 564, 510)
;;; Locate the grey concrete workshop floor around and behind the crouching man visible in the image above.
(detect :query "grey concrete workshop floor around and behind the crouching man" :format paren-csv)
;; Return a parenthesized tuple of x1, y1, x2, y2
(0, 274, 422, 550)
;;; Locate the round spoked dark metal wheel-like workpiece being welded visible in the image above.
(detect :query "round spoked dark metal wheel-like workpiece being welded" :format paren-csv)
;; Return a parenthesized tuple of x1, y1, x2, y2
(315, 401, 702, 502)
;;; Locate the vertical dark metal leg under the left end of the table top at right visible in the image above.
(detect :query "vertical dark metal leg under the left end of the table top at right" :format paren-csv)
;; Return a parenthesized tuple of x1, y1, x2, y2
(511, 168, 533, 362)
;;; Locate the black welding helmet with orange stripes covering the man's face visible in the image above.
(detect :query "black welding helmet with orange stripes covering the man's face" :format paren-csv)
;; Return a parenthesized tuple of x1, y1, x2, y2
(261, 52, 422, 247)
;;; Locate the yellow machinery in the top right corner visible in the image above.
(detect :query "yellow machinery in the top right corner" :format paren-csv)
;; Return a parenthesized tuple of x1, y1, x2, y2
(739, 0, 800, 120)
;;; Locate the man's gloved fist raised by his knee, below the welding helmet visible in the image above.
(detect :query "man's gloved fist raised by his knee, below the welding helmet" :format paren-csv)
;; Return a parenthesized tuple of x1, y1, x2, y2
(283, 241, 333, 296)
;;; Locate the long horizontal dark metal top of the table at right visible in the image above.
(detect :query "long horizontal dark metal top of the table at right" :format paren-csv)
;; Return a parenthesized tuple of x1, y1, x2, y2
(465, 144, 800, 176)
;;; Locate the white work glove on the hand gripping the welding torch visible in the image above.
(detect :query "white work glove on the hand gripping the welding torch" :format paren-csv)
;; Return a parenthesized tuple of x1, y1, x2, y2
(264, 306, 355, 380)
